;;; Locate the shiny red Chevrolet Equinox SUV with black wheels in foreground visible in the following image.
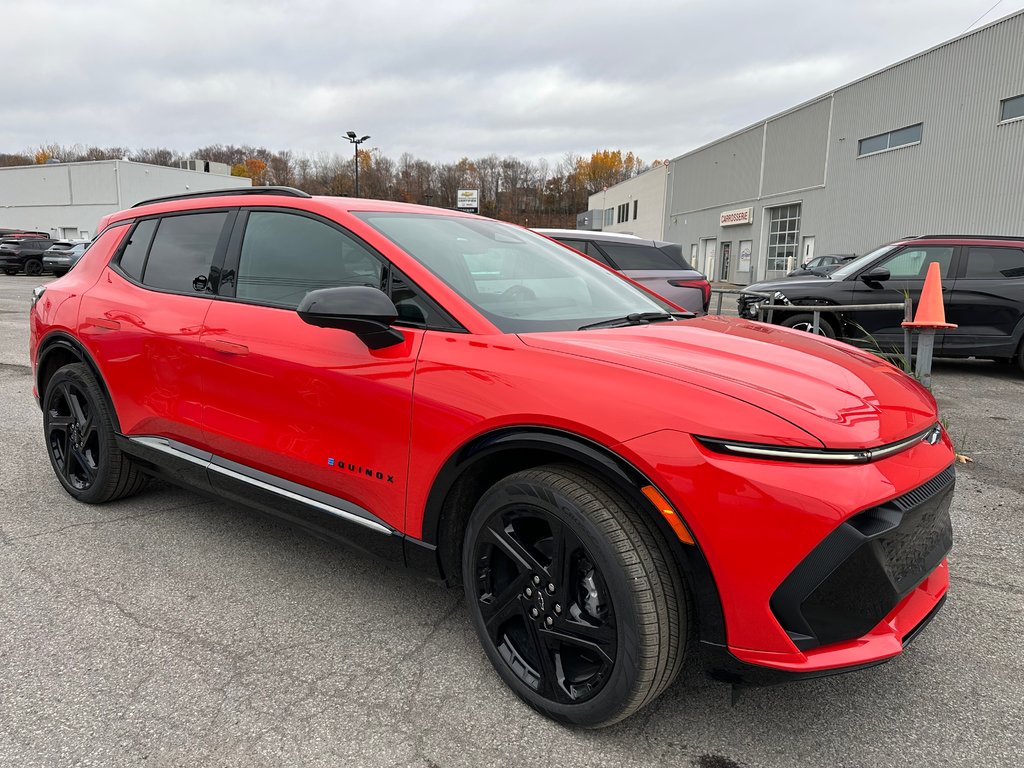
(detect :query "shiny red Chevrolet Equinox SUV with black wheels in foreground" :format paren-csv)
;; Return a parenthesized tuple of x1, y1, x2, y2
(31, 187, 954, 727)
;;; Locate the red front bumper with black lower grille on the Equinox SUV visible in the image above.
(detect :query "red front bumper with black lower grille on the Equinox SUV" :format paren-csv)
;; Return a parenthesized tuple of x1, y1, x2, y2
(610, 432, 953, 679)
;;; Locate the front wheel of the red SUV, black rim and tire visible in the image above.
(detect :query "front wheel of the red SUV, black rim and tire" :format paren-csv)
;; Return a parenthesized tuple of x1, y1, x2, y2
(463, 465, 689, 728)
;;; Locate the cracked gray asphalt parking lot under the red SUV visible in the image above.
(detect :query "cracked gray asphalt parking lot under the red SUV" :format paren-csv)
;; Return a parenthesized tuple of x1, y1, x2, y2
(0, 275, 1024, 768)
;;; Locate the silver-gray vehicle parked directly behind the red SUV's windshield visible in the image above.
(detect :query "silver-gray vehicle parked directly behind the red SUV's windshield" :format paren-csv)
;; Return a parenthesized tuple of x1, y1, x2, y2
(534, 229, 711, 314)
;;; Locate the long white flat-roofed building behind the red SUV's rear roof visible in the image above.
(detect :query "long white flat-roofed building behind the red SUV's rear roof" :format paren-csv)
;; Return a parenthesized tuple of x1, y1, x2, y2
(0, 160, 252, 239)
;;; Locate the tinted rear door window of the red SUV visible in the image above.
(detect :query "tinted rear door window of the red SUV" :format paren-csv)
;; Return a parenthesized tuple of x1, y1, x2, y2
(142, 211, 228, 293)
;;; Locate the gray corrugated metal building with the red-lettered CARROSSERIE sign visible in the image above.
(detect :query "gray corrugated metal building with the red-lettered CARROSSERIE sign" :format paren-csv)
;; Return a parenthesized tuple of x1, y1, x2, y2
(665, 11, 1024, 284)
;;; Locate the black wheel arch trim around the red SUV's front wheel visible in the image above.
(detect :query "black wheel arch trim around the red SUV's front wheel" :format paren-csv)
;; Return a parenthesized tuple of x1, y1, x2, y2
(422, 427, 725, 643)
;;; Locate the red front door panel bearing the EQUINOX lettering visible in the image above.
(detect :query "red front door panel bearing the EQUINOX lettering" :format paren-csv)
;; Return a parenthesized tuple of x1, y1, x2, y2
(201, 301, 424, 528)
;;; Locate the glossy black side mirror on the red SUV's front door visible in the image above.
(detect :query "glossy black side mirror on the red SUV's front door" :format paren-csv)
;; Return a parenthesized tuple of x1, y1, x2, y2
(295, 286, 404, 349)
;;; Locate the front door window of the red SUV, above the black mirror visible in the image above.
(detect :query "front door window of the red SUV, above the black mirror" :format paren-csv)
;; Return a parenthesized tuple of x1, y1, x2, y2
(234, 211, 383, 308)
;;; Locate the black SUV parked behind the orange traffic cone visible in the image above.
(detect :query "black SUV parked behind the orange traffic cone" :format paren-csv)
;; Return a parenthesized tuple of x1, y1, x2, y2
(738, 234, 1024, 370)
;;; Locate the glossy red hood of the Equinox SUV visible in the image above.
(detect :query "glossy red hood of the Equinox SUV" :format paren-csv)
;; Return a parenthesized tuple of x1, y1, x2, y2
(521, 316, 937, 449)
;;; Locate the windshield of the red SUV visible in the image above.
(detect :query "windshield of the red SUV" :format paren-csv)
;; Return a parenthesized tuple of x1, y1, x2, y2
(355, 212, 678, 333)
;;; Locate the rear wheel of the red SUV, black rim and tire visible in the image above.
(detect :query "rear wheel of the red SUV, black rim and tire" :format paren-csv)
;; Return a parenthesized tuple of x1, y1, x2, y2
(43, 362, 146, 504)
